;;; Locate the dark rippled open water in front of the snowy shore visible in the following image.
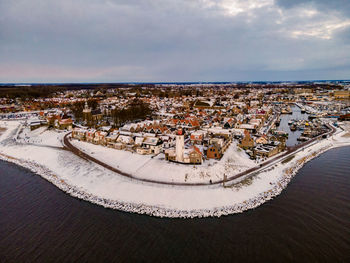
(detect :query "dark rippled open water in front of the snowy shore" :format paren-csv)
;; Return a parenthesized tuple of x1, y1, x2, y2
(0, 147, 350, 262)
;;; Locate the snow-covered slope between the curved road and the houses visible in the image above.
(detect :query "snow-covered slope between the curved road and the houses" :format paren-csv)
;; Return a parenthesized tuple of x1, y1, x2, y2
(71, 140, 256, 183)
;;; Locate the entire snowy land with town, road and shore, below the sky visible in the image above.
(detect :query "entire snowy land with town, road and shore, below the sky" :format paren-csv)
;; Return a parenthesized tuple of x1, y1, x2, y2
(0, 81, 350, 217)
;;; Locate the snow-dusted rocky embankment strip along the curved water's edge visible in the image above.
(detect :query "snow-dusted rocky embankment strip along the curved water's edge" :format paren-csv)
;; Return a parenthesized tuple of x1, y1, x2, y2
(0, 144, 347, 218)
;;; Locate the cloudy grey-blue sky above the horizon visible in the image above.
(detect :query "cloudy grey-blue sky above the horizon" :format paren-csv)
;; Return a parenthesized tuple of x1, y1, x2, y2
(0, 0, 350, 83)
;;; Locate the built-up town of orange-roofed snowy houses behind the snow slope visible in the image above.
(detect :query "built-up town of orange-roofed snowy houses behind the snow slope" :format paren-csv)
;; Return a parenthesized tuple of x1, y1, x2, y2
(0, 83, 350, 165)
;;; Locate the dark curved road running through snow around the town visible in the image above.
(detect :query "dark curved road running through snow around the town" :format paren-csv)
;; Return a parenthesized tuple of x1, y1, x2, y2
(63, 124, 336, 186)
